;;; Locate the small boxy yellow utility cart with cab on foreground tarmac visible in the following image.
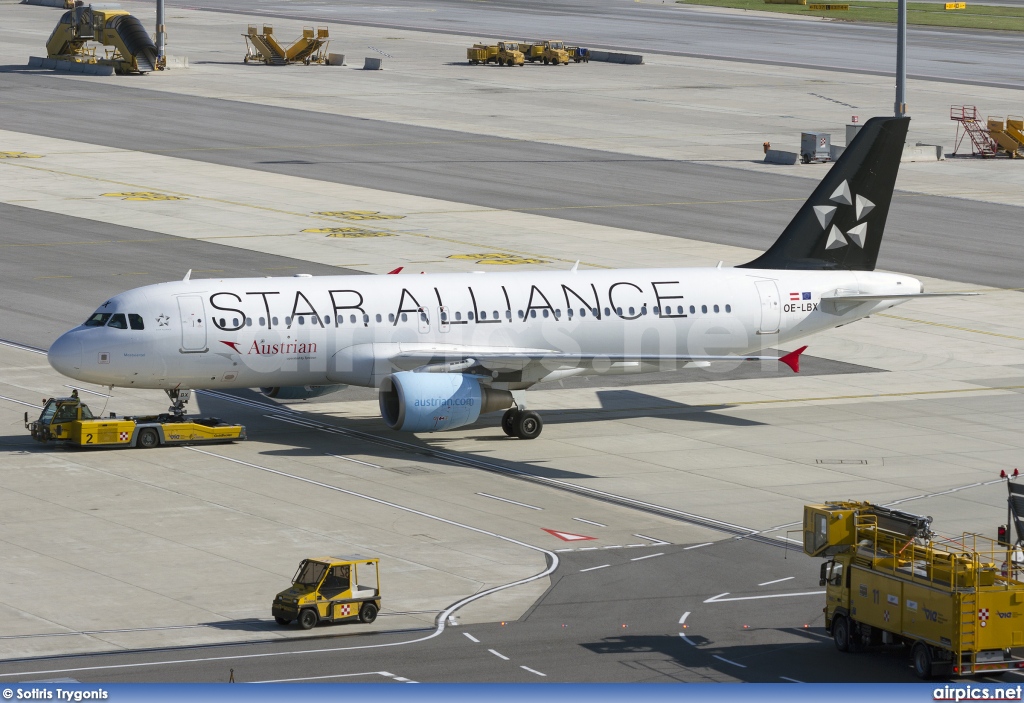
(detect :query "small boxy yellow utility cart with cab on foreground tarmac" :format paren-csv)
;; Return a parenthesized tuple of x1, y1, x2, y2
(270, 557, 381, 629)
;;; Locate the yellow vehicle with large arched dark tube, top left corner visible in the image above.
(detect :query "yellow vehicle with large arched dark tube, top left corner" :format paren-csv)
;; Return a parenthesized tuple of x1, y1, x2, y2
(46, 6, 163, 74)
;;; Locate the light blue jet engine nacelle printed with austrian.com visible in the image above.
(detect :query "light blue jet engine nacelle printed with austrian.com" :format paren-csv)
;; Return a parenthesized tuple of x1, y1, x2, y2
(380, 371, 513, 432)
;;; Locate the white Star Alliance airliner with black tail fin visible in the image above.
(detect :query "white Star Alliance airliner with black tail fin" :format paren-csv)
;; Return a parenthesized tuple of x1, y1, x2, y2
(49, 118, 962, 439)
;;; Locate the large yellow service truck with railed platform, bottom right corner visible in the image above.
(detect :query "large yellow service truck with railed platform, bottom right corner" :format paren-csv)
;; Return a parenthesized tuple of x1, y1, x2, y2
(803, 501, 1024, 678)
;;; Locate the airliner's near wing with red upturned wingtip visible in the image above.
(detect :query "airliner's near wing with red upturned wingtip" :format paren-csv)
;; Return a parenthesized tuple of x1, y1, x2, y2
(390, 346, 807, 372)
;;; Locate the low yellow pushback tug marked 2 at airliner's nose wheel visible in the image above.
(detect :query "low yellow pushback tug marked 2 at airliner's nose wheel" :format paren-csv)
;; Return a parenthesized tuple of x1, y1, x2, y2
(25, 397, 246, 449)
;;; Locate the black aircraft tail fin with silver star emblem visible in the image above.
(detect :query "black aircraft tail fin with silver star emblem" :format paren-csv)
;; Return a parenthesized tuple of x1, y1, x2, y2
(739, 118, 910, 271)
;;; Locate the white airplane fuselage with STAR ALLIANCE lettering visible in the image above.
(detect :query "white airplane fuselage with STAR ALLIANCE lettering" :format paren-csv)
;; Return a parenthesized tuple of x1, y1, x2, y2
(49, 268, 922, 389)
